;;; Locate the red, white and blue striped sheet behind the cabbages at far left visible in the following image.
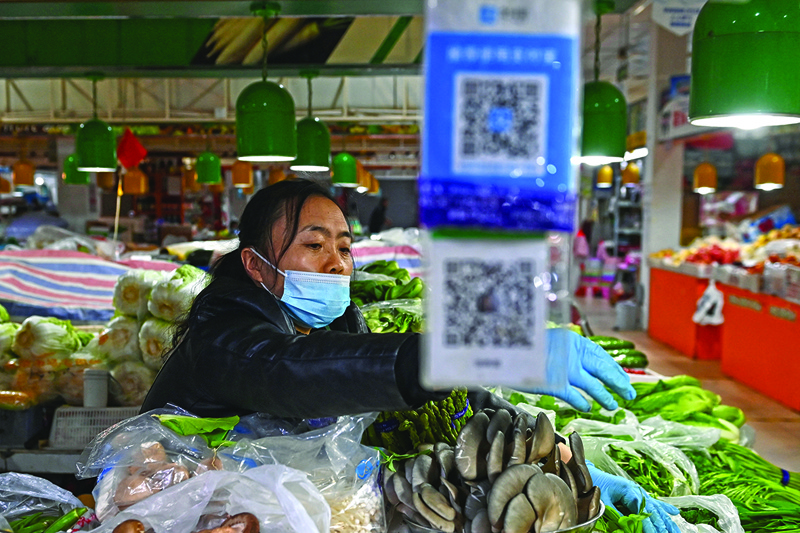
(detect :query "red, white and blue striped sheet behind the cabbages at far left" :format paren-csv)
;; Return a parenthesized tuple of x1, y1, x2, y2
(0, 250, 177, 322)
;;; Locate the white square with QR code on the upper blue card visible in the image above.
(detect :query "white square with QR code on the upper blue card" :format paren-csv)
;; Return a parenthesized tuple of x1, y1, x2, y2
(453, 73, 548, 177)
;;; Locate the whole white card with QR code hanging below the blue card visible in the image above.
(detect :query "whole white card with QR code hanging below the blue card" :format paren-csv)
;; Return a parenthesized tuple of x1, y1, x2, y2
(421, 238, 548, 387)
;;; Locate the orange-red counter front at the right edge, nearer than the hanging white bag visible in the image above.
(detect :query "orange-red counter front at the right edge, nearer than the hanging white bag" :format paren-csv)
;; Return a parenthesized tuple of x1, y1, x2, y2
(718, 284, 800, 410)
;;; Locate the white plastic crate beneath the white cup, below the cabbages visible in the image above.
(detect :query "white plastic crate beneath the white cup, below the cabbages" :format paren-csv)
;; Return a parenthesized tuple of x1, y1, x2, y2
(49, 407, 139, 450)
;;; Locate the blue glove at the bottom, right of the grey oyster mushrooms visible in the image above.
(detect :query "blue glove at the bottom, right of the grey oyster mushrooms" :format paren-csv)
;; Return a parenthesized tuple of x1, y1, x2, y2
(586, 461, 680, 533)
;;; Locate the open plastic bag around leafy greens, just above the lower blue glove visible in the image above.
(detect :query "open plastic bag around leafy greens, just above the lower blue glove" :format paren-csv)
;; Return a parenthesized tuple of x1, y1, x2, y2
(581, 436, 700, 496)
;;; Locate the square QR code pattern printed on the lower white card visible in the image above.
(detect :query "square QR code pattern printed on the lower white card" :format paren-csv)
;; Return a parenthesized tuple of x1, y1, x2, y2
(444, 259, 536, 348)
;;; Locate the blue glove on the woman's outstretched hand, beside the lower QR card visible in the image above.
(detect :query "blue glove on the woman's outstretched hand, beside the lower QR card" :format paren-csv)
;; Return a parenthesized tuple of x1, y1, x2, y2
(531, 328, 636, 411)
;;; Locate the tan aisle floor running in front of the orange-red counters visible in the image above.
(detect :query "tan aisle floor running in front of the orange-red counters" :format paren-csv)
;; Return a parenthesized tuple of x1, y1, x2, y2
(578, 298, 800, 472)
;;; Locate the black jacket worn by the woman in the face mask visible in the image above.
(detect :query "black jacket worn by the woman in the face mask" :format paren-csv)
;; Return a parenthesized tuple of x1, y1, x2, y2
(142, 277, 445, 418)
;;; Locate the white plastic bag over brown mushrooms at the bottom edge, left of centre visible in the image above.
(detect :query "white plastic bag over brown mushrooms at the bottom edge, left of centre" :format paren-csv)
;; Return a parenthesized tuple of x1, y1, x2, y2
(84, 465, 330, 533)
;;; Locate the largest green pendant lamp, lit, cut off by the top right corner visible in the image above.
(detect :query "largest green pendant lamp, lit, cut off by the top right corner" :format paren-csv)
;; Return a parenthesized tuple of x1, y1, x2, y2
(689, 0, 800, 129)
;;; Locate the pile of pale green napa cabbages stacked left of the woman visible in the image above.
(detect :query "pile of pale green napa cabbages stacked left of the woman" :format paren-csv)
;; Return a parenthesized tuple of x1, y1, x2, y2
(0, 265, 205, 409)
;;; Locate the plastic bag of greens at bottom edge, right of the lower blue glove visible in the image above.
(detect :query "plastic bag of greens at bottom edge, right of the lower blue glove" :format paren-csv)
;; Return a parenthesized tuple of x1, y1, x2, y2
(661, 494, 744, 533)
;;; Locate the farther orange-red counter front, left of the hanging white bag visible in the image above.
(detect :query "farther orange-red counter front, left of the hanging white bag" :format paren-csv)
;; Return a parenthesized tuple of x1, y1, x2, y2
(648, 267, 722, 359)
